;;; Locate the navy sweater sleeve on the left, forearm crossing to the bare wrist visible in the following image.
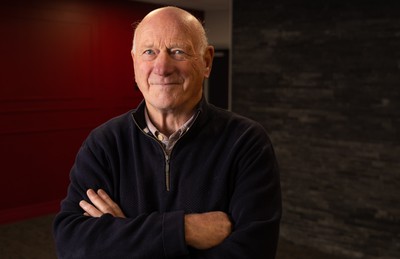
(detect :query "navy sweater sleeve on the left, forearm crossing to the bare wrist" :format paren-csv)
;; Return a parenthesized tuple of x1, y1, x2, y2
(53, 133, 188, 259)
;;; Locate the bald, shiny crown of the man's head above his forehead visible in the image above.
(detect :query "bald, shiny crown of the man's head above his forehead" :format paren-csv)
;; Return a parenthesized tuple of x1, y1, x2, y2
(132, 6, 208, 54)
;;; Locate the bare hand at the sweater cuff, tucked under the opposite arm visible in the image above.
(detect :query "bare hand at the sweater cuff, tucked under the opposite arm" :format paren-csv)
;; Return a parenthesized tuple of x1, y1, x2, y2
(185, 211, 232, 249)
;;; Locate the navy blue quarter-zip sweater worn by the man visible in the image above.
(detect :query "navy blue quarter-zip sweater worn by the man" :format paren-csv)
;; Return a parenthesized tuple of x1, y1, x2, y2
(54, 100, 281, 259)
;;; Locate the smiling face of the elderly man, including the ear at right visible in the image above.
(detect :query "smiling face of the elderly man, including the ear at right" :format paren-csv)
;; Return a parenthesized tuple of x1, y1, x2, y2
(132, 14, 213, 112)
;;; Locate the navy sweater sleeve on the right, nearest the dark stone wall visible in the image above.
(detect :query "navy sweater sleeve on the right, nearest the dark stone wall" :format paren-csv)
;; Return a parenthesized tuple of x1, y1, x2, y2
(191, 124, 282, 259)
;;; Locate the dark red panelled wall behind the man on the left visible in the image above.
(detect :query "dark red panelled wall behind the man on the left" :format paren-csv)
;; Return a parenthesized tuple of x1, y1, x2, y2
(0, 1, 203, 223)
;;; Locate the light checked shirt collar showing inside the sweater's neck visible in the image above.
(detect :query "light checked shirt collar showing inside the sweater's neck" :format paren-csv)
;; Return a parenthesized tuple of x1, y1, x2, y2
(144, 109, 195, 155)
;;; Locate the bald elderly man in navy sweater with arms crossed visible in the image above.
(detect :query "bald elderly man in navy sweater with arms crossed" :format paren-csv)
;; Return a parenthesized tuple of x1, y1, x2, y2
(54, 7, 281, 259)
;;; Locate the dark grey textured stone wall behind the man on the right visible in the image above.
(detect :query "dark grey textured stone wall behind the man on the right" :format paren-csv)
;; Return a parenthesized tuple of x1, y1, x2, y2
(232, 0, 400, 259)
